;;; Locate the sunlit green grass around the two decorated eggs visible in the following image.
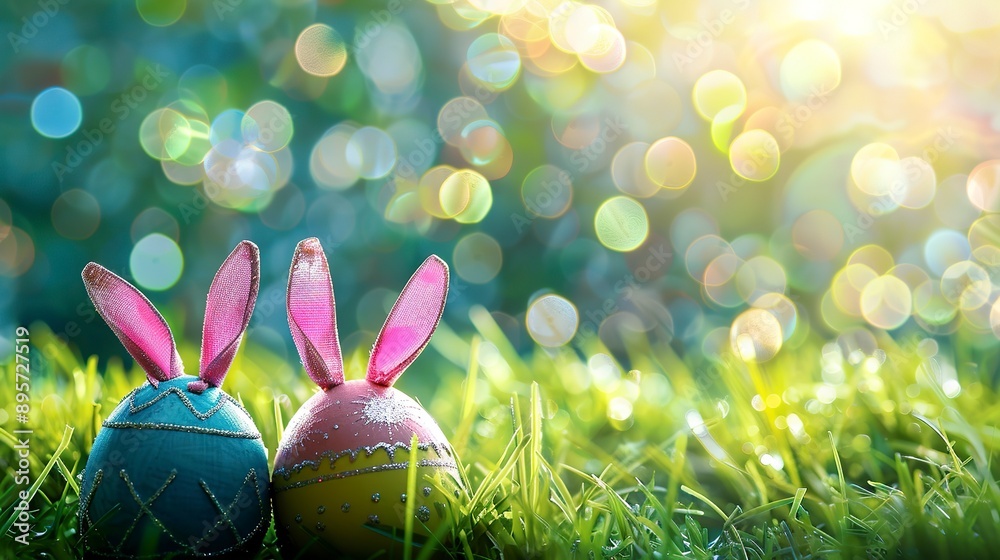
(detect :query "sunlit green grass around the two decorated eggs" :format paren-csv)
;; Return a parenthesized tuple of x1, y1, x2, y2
(0, 309, 1000, 559)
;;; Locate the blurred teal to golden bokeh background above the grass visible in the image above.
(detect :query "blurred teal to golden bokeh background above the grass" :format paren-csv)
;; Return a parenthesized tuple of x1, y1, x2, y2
(0, 0, 1000, 380)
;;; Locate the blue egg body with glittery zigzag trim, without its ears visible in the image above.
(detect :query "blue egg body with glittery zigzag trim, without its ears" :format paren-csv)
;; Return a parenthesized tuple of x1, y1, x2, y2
(79, 375, 271, 558)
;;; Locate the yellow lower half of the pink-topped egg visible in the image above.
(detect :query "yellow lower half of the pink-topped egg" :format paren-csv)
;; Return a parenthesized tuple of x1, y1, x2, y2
(272, 447, 459, 558)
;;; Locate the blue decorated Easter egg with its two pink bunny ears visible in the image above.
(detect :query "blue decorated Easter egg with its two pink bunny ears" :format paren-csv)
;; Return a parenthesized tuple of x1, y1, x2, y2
(79, 241, 271, 558)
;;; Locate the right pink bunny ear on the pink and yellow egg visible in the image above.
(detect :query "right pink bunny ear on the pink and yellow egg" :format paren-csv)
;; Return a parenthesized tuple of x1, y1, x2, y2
(368, 255, 448, 387)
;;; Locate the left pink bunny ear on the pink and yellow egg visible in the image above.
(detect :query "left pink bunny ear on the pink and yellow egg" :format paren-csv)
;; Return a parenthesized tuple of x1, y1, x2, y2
(287, 237, 344, 389)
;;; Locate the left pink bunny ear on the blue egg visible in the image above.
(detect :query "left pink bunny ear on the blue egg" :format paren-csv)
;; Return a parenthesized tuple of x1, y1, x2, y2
(83, 263, 184, 387)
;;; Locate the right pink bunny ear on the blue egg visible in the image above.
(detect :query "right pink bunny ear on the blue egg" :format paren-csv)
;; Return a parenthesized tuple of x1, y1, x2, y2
(197, 241, 260, 392)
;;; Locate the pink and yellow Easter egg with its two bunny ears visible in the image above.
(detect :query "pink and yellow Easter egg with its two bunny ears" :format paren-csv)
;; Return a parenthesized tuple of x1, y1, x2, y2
(271, 239, 462, 558)
